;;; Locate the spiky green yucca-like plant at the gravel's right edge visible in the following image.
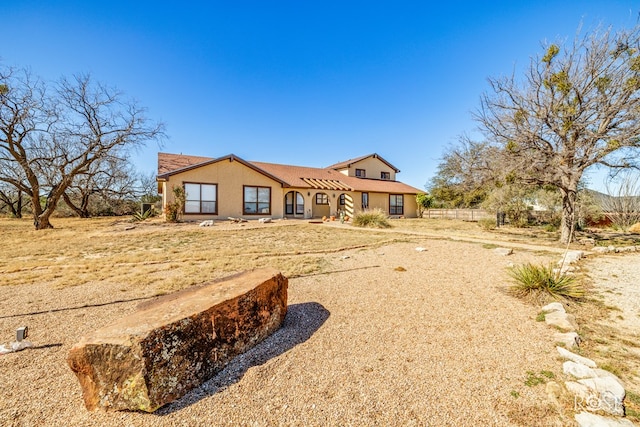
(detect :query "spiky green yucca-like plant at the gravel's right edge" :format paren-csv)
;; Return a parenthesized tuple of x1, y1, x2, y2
(509, 263, 584, 299)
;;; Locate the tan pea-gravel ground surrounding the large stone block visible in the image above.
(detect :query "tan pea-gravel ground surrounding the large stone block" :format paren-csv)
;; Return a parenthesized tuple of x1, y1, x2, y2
(0, 238, 562, 426)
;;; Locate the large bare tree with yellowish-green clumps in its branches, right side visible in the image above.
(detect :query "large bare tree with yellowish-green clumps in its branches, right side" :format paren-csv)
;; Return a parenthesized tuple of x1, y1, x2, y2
(475, 27, 640, 242)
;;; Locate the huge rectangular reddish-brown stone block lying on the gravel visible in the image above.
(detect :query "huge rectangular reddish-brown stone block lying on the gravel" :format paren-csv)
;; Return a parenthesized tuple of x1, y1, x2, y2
(67, 269, 288, 412)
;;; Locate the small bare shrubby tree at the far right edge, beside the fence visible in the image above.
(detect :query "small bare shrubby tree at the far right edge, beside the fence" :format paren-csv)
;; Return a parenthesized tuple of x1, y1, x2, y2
(599, 171, 640, 231)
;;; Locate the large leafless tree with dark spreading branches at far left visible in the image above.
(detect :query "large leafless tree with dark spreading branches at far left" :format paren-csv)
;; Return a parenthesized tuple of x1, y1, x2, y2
(0, 68, 162, 229)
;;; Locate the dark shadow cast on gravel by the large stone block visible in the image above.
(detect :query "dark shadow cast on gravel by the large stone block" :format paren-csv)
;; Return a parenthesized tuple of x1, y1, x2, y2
(154, 302, 330, 416)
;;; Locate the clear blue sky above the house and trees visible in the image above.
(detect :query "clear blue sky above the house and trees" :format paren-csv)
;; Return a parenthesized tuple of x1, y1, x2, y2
(0, 0, 640, 189)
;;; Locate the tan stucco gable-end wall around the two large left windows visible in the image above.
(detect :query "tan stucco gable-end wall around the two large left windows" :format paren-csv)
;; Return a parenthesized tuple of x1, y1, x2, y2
(162, 160, 289, 220)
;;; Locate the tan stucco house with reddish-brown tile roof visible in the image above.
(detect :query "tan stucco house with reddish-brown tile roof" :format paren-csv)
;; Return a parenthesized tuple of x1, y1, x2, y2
(157, 153, 423, 220)
